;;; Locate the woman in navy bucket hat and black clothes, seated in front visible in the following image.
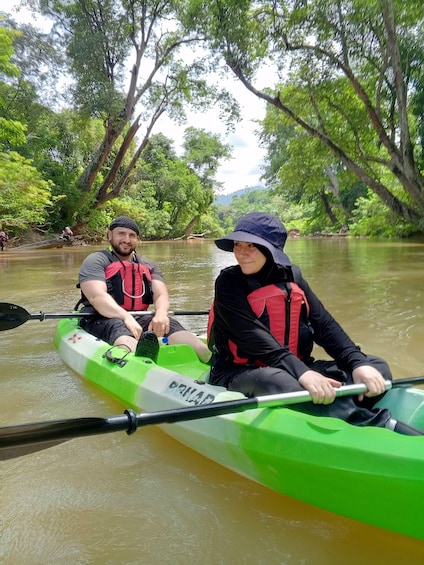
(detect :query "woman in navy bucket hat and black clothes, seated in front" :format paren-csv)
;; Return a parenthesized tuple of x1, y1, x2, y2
(209, 212, 421, 435)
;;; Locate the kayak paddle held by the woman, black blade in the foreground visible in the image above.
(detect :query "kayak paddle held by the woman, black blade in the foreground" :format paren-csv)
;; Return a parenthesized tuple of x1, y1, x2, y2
(0, 381, 392, 461)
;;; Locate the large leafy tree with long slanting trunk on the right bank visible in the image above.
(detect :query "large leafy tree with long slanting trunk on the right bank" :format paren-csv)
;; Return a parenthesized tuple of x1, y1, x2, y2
(192, 0, 424, 230)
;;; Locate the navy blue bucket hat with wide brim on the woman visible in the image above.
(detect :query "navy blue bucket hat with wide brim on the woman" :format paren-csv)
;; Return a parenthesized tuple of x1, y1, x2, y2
(215, 212, 291, 267)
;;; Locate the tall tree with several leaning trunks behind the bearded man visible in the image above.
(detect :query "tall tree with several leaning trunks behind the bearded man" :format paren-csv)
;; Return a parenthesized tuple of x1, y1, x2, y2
(26, 0, 238, 223)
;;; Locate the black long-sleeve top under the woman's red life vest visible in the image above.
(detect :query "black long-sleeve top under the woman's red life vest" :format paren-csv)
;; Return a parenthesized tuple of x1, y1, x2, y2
(211, 261, 367, 386)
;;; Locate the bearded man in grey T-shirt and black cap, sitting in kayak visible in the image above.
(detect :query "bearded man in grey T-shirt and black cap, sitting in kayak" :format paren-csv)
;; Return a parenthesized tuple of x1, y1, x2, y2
(79, 216, 211, 362)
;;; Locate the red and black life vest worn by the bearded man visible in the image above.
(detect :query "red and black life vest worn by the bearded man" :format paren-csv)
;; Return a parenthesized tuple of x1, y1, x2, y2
(80, 249, 153, 312)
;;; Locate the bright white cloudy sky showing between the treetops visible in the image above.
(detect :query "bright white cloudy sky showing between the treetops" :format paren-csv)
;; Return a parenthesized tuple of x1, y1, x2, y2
(1, 0, 265, 194)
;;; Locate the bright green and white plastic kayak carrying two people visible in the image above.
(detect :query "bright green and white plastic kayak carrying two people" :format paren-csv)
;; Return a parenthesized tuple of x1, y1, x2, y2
(54, 319, 424, 539)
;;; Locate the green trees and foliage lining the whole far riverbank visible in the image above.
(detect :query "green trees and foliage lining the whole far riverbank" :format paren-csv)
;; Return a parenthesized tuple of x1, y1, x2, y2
(4, 0, 424, 239)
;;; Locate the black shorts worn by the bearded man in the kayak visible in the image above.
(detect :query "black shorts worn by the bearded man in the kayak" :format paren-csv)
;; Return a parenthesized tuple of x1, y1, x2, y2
(80, 312, 185, 345)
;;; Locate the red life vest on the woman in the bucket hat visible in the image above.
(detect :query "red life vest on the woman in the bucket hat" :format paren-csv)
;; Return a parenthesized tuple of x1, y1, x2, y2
(208, 282, 309, 366)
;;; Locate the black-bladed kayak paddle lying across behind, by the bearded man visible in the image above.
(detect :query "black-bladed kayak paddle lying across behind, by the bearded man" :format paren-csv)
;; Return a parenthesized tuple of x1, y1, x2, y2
(0, 302, 209, 331)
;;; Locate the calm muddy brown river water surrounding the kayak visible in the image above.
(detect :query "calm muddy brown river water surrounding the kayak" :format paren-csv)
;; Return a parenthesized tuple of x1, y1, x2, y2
(0, 239, 424, 565)
